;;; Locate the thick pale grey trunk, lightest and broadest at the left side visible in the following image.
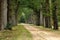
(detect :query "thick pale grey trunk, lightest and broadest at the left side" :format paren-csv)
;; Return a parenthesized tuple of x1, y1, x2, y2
(2, 0, 7, 29)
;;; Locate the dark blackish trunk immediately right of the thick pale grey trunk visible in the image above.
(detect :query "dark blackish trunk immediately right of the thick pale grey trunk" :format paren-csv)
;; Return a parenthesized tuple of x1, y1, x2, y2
(6, 0, 12, 30)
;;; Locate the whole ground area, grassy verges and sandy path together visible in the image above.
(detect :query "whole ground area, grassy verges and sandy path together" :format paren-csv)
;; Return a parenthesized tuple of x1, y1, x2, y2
(0, 24, 60, 40)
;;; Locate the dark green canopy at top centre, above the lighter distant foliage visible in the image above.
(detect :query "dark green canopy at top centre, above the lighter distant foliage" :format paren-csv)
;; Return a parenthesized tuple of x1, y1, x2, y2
(19, 0, 41, 9)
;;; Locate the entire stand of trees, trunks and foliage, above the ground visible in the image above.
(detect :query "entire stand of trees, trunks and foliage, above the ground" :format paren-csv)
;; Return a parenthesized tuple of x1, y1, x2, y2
(0, 0, 60, 30)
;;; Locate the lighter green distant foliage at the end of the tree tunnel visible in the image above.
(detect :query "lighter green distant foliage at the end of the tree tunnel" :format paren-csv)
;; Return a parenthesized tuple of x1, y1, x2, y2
(18, 7, 33, 21)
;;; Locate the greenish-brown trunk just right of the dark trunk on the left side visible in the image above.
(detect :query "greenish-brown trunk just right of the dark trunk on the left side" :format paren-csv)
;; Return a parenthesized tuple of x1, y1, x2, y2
(10, 0, 17, 26)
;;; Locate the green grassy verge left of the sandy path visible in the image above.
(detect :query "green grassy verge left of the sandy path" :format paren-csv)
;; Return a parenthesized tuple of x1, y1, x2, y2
(0, 25, 32, 40)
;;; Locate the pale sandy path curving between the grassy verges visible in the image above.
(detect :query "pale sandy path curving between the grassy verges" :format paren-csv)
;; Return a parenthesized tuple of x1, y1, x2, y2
(24, 24, 60, 40)
